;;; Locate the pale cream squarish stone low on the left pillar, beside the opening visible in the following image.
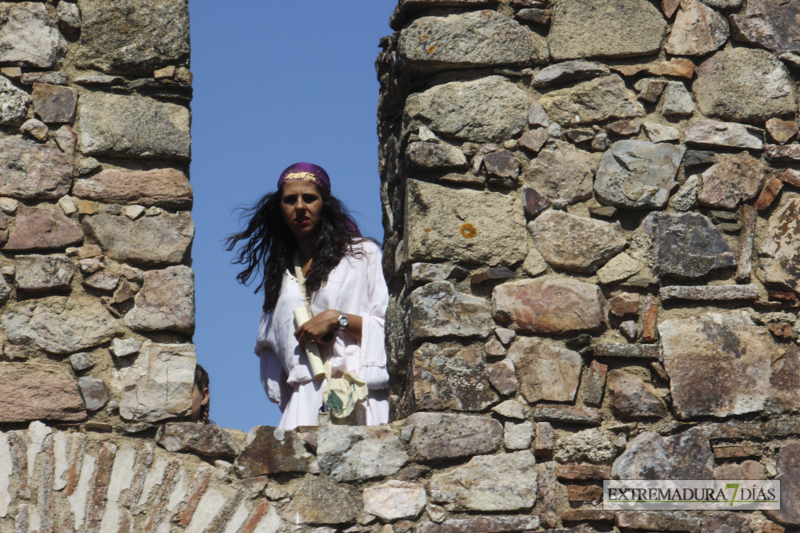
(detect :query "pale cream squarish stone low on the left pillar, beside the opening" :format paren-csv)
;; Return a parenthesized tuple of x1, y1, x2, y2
(119, 343, 196, 422)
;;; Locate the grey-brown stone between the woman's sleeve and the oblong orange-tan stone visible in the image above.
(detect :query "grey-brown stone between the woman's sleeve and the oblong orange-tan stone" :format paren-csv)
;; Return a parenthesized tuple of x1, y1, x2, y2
(410, 281, 494, 340)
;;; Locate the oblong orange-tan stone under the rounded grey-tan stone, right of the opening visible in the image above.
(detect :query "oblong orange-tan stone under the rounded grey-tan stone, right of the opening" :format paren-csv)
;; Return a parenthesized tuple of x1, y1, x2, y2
(492, 276, 607, 333)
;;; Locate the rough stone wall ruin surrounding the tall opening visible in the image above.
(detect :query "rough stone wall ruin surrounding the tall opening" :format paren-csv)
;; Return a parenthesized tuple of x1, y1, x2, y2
(0, 0, 800, 533)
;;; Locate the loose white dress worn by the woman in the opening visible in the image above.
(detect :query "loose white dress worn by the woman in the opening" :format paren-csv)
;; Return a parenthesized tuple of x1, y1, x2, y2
(255, 241, 389, 429)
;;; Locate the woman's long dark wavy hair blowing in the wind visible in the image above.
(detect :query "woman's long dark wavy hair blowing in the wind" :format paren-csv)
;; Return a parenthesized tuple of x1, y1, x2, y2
(226, 185, 365, 313)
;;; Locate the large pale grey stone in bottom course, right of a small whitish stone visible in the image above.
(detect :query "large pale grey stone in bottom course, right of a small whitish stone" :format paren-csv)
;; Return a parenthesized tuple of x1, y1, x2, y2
(430, 452, 537, 511)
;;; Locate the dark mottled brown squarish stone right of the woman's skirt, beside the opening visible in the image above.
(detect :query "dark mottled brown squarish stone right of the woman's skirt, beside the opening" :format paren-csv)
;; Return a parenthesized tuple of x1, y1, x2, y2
(414, 343, 502, 411)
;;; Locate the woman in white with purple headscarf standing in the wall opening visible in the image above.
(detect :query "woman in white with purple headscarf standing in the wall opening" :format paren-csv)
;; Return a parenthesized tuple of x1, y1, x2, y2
(228, 163, 389, 429)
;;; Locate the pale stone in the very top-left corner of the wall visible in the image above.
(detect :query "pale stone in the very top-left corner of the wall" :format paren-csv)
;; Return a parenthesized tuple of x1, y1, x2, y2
(0, 2, 66, 68)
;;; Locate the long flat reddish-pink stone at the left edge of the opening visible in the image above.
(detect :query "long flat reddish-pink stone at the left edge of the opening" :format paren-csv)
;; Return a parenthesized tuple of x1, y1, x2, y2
(72, 169, 195, 209)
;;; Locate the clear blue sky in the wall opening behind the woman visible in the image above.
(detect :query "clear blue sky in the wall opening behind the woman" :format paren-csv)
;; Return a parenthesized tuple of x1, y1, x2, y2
(189, 0, 396, 431)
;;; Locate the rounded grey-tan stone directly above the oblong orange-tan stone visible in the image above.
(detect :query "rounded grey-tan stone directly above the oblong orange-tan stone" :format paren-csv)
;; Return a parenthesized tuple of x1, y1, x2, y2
(529, 210, 627, 273)
